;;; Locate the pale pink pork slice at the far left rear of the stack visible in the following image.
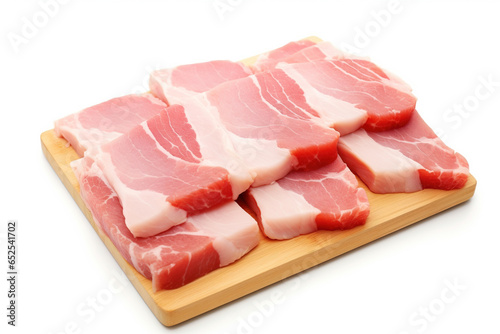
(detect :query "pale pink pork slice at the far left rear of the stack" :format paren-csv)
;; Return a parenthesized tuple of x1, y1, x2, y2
(54, 94, 166, 156)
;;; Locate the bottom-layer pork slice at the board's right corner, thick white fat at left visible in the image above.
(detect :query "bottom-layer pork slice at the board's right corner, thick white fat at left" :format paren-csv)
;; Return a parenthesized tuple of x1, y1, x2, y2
(338, 111, 469, 193)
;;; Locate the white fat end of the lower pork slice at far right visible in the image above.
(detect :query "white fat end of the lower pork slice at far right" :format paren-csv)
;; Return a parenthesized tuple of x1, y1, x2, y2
(339, 130, 423, 193)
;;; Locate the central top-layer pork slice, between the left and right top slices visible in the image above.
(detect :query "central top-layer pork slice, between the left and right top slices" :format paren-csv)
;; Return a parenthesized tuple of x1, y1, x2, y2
(205, 70, 339, 186)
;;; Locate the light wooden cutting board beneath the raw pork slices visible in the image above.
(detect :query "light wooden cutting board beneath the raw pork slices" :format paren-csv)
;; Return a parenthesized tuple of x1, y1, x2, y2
(41, 37, 476, 326)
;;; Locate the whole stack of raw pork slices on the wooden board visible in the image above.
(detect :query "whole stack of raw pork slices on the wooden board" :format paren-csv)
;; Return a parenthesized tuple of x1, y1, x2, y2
(55, 40, 468, 291)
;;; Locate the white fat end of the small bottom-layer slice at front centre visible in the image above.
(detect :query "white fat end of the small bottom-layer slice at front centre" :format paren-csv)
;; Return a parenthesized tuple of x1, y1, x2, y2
(249, 183, 321, 240)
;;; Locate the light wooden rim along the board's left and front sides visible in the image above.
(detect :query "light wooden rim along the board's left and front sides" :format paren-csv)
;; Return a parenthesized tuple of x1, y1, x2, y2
(41, 130, 477, 326)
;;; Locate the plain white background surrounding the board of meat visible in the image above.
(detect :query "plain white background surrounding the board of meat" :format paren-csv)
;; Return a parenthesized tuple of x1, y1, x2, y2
(0, 0, 500, 334)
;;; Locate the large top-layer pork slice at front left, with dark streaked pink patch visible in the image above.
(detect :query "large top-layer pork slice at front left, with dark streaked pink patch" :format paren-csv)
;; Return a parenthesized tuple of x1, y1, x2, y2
(91, 105, 253, 237)
